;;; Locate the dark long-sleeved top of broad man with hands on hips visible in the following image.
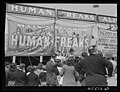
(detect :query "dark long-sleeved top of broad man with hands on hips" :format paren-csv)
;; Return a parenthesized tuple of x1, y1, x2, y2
(75, 55, 113, 86)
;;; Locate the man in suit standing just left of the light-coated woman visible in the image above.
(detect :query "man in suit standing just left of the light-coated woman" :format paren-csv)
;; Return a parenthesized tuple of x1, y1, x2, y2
(46, 54, 59, 86)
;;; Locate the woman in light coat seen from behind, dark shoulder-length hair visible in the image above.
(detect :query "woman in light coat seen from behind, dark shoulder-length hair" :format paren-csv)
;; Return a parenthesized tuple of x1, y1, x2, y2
(60, 58, 79, 86)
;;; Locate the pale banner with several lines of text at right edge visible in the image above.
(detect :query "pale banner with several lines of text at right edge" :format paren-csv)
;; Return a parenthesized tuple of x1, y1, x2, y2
(97, 28, 117, 55)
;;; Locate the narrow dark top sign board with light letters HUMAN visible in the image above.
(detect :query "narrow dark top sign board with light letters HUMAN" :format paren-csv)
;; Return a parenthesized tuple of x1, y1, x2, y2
(6, 4, 56, 17)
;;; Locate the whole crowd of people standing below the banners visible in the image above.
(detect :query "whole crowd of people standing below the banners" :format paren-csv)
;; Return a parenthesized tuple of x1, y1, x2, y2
(5, 46, 117, 86)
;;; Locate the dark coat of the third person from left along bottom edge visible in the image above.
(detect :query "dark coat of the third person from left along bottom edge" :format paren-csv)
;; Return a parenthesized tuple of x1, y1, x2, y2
(27, 72, 39, 86)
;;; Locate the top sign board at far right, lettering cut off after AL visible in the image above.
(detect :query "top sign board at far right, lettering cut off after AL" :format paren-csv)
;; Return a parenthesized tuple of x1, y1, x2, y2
(98, 15, 117, 24)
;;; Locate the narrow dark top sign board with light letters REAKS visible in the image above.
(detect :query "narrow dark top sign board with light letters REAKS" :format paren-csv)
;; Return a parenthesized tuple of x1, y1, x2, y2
(57, 9, 96, 22)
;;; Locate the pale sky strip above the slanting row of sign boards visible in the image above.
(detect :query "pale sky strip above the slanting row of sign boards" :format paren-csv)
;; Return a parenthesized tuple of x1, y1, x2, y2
(19, 3, 117, 17)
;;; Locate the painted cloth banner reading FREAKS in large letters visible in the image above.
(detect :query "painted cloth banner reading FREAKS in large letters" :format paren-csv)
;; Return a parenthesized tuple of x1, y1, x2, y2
(56, 24, 93, 55)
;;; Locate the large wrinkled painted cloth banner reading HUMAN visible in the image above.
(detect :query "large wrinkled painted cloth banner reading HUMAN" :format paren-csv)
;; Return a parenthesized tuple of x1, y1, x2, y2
(6, 19, 54, 56)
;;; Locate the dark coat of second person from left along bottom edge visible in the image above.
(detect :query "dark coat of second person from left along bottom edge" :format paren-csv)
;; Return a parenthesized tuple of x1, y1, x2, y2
(15, 70, 26, 86)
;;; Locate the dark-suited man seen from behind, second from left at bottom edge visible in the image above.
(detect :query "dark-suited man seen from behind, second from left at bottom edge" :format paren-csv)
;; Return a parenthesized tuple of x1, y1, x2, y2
(14, 64, 26, 86)
